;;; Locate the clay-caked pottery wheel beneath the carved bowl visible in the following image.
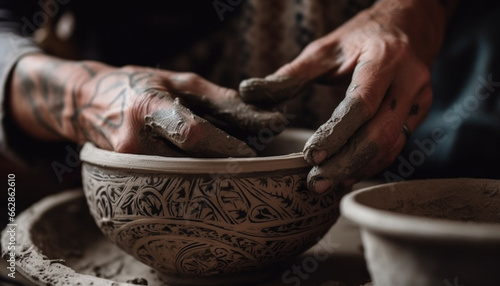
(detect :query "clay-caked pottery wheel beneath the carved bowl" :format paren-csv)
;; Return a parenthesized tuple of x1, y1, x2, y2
(2, 190, 369, 286)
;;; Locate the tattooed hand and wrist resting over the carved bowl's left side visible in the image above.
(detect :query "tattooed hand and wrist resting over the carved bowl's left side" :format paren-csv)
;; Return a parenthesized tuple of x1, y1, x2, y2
(10, 54, 285, 157)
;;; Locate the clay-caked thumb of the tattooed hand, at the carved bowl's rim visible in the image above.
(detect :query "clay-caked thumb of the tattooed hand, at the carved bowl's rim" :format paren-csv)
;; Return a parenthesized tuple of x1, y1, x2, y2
(140, 98, 255, 157)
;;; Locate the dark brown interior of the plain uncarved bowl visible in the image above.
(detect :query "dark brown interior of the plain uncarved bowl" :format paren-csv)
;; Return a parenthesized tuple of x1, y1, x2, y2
(355, 179, 500, 224)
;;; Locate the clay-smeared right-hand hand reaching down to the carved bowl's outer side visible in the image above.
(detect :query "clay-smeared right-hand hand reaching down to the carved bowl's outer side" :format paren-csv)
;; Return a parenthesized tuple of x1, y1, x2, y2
(240, 0, 454, 192)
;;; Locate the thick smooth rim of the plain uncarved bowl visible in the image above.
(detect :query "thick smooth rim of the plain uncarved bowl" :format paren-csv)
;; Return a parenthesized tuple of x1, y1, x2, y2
(340, 178, 500, 243)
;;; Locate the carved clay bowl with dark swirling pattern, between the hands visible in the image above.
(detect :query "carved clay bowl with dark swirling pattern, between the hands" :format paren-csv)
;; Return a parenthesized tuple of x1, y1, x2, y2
(81, 130, 340, 285)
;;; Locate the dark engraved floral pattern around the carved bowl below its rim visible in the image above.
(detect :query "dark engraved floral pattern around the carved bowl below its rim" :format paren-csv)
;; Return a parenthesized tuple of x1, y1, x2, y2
(83, 163, 339, 277)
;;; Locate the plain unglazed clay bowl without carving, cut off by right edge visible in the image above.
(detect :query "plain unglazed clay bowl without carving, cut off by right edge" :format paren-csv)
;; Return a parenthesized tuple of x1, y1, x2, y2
(341, 178, 500, 286)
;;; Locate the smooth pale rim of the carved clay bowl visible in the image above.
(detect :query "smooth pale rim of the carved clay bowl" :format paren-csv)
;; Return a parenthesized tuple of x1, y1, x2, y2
(80, 128, 313, 174)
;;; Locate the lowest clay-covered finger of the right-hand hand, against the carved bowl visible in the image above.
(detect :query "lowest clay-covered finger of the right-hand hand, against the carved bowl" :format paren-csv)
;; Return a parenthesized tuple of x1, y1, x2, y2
(308, 81, 432, 192)
